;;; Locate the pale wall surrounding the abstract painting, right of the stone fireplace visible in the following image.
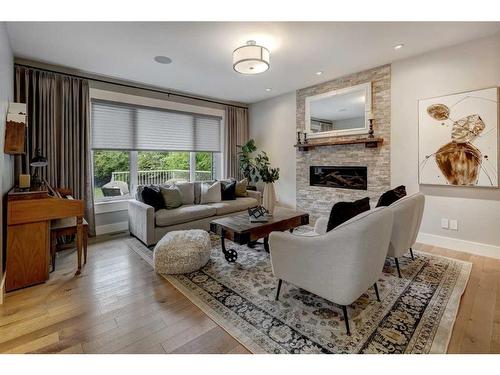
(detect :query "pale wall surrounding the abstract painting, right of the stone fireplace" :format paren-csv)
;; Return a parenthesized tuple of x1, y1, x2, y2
(391, 34, 500, 257)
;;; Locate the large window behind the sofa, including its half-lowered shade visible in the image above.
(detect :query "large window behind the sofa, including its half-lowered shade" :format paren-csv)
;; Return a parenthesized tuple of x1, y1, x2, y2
(91, 99, 222, 201)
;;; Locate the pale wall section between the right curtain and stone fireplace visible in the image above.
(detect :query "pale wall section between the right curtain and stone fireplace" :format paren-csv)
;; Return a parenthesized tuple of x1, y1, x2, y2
(249, 92, 297, 208)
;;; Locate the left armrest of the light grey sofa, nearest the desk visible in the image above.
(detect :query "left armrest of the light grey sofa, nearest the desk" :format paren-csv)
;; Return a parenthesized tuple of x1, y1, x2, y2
(128, 199, 155, 246)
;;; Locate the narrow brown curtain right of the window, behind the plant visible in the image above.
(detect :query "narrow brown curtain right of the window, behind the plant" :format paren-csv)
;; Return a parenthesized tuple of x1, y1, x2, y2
(225, 107, 248, 180)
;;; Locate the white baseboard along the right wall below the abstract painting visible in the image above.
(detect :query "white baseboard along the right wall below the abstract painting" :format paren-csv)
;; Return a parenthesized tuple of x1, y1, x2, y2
(417, 232, 500, 259)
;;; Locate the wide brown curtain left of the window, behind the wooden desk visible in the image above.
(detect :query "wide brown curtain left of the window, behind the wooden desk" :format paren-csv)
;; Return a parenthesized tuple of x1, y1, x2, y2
(14, 66, 95, 235)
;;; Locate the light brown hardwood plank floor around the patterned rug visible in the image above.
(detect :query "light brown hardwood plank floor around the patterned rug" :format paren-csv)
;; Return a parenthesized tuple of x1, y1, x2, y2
(0, 236, 500, 353)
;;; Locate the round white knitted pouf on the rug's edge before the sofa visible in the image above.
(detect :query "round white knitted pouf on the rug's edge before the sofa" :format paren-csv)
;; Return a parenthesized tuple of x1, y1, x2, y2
(153, 229, 212, 274)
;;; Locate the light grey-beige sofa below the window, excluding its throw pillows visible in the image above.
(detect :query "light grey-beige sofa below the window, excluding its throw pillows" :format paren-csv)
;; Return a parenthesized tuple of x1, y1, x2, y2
(128, 182, 261, 246)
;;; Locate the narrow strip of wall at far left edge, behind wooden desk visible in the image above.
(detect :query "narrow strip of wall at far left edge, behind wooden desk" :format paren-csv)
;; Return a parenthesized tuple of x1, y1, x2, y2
(0, 22, 14, 290)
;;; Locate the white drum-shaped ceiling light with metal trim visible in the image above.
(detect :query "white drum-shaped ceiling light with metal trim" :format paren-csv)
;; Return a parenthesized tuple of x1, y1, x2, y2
(233, 40, 269, 74)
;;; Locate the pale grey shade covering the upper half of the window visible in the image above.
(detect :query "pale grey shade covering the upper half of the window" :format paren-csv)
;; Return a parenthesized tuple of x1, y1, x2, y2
(92, 100, 221, 152)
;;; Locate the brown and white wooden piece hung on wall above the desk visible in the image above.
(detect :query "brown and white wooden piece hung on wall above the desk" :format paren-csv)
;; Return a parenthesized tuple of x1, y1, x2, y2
(4, 103, 27, 155)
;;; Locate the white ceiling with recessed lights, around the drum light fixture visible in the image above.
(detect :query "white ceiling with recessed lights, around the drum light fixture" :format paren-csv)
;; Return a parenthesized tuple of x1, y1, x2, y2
(7, 22, 500, 103)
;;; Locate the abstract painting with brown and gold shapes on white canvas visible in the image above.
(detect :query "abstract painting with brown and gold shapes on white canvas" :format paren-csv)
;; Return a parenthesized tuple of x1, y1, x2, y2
(418, 88, 498, 187)
